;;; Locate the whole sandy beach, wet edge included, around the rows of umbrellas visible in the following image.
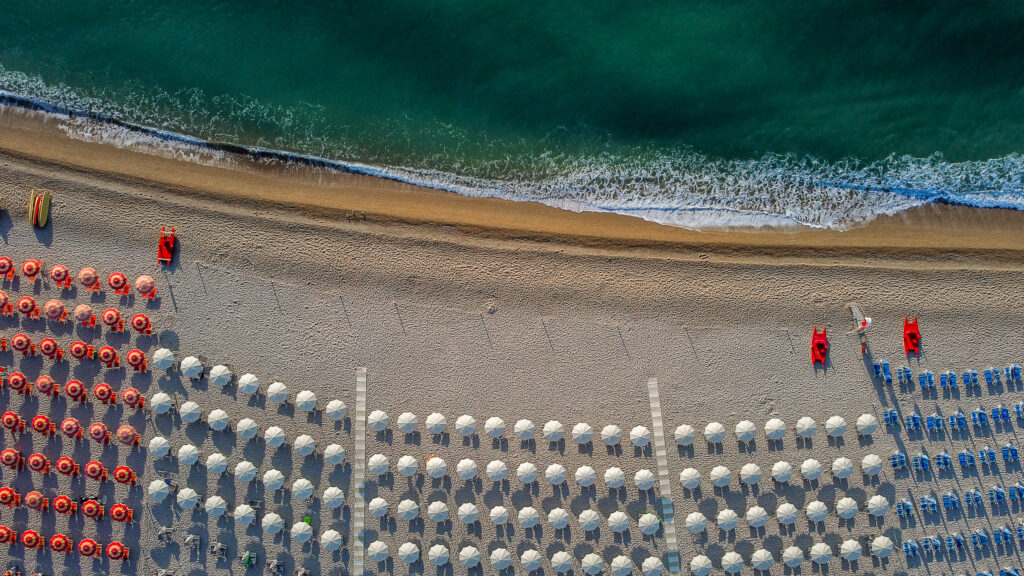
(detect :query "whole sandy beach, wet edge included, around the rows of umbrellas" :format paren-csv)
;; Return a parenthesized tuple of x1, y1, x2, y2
(0, 104, 1024, 574)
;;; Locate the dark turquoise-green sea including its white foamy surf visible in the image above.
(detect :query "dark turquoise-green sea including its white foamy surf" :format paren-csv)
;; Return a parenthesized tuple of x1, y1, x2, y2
(0, 0, 1024, 227)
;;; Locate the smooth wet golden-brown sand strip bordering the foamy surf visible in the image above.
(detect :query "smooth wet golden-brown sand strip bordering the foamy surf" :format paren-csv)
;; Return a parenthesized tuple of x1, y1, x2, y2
(0, 106, 1024, 263)
